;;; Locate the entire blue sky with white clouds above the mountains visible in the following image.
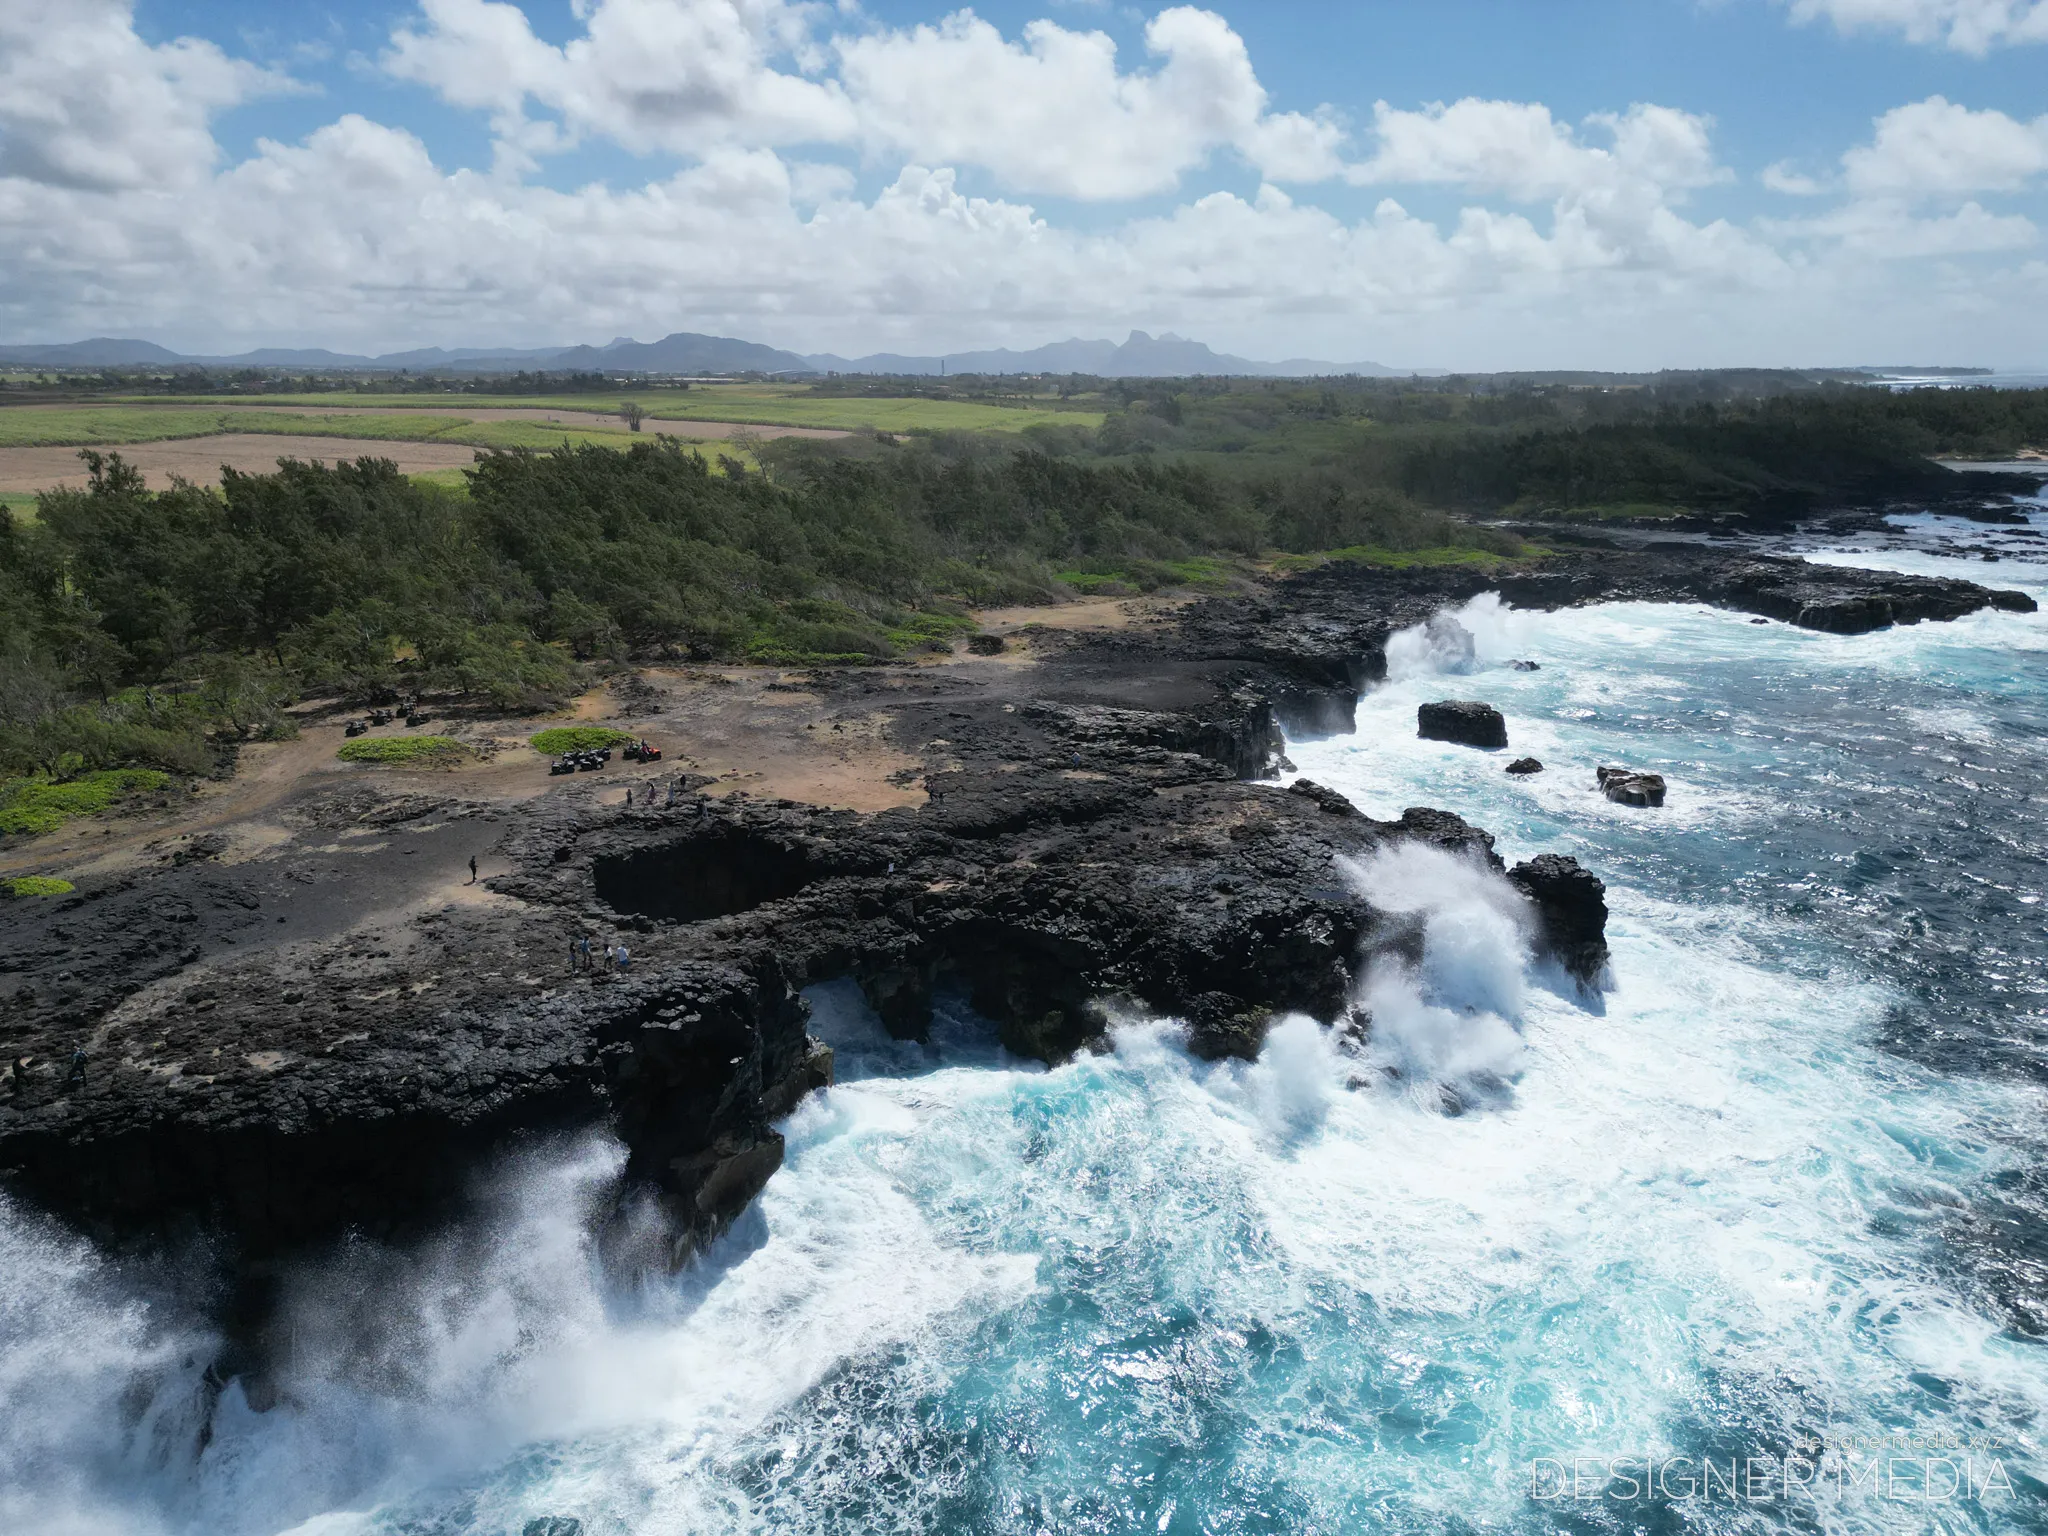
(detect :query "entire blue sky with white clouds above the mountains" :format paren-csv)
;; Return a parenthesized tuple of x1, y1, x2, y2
(0, 0, 2048, 371)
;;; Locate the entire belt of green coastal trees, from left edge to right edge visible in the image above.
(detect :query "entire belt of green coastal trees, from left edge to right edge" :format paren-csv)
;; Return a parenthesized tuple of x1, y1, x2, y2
(0, 375, 2048, 806)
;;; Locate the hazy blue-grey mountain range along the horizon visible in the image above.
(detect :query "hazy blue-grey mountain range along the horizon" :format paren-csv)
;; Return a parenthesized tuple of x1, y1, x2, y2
(0, 330, 1403, 379)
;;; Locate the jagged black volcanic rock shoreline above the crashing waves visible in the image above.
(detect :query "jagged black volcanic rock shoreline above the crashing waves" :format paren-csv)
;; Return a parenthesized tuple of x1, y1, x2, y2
(0, 547, 2032, 1274)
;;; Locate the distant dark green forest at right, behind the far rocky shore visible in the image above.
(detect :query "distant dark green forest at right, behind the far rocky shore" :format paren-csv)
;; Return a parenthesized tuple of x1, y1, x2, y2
(1073, 375, 2048, 516)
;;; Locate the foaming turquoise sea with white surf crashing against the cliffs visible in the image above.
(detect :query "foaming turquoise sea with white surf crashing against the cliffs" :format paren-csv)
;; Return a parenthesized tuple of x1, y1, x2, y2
(0, 514, 2048, 1536)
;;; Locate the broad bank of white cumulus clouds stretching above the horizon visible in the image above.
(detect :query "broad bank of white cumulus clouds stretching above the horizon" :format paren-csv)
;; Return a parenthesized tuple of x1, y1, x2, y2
(0, 0, 2048, 367)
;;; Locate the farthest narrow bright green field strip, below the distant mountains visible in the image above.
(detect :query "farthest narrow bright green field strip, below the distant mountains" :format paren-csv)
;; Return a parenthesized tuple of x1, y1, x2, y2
(99, 385, 1102, 442)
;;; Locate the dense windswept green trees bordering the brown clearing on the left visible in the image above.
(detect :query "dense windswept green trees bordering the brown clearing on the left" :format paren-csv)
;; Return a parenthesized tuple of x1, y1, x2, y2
(0, 438, 1518, 776)
